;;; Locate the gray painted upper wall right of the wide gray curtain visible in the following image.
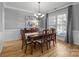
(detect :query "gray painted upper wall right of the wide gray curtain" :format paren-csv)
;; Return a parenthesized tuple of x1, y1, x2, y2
(73, 4, 79, 31)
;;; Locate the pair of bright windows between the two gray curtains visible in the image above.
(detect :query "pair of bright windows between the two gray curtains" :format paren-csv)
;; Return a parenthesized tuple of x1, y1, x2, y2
(48, 13, 67, 36)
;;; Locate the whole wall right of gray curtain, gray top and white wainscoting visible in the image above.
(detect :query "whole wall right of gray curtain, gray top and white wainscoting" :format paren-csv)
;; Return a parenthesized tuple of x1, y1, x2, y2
(73, 4, 79, 45)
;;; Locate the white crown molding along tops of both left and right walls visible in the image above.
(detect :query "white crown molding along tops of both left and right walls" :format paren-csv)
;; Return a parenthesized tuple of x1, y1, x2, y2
(3, 2, 79, 14)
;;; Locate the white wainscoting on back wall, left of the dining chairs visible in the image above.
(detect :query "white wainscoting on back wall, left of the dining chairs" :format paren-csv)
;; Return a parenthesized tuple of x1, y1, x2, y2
(4, 29, 20, 41)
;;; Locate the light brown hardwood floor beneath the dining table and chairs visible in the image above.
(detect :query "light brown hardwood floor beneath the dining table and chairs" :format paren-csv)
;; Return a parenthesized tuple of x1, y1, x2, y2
(1, 40, 79, 57)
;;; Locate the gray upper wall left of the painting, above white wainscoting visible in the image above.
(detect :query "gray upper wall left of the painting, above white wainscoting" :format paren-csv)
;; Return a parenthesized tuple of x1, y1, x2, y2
(5, 8, 31, 30)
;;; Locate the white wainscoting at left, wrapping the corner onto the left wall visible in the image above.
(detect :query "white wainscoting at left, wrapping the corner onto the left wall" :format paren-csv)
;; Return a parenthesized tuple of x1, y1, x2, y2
(0, 29, 20, 52)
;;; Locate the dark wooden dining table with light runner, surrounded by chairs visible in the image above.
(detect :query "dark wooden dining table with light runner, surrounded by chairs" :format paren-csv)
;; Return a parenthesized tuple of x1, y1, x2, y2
(25, 32, 53, 52)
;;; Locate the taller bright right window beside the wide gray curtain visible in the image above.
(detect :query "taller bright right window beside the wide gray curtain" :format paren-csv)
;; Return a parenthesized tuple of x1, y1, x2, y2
(57, 14, 67, 36)
